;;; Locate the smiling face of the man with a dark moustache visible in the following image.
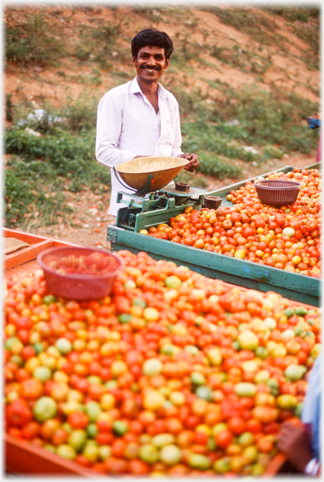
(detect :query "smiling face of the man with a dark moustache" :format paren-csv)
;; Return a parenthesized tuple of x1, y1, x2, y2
(132, 45, 169, 82)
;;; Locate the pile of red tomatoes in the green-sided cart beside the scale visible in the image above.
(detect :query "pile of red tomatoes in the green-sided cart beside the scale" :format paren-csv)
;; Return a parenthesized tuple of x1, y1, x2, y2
(140, 168, 321, 278)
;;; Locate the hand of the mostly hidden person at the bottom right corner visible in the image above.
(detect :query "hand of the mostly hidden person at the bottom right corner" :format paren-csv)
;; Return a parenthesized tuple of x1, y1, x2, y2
(278, 422, 313, 472)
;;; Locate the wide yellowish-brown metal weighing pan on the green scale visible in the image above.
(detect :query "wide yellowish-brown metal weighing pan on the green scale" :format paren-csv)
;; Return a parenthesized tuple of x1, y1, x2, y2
(116, 156, 189, 192)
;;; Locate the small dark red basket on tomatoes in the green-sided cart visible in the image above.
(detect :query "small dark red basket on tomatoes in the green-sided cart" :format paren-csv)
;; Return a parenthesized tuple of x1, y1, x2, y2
(254, 179, 302, 206)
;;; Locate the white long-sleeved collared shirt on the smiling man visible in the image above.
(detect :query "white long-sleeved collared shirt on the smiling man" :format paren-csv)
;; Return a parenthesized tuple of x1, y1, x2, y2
(96, 77, 182, 216)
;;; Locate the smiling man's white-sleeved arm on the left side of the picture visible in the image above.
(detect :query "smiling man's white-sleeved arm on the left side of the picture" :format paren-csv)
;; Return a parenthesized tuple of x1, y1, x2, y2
(96, 94, 135, 167)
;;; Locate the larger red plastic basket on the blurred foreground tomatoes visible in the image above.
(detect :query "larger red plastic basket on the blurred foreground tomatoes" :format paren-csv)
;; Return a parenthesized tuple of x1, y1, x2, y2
(37, 247, 124, 300)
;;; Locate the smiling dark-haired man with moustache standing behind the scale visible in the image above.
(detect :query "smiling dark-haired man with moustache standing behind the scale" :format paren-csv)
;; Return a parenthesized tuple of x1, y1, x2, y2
(96, 28, 199, 216)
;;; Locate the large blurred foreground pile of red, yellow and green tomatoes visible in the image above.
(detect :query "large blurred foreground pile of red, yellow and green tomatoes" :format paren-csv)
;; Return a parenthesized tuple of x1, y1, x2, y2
(3, 251, 321, 477)
